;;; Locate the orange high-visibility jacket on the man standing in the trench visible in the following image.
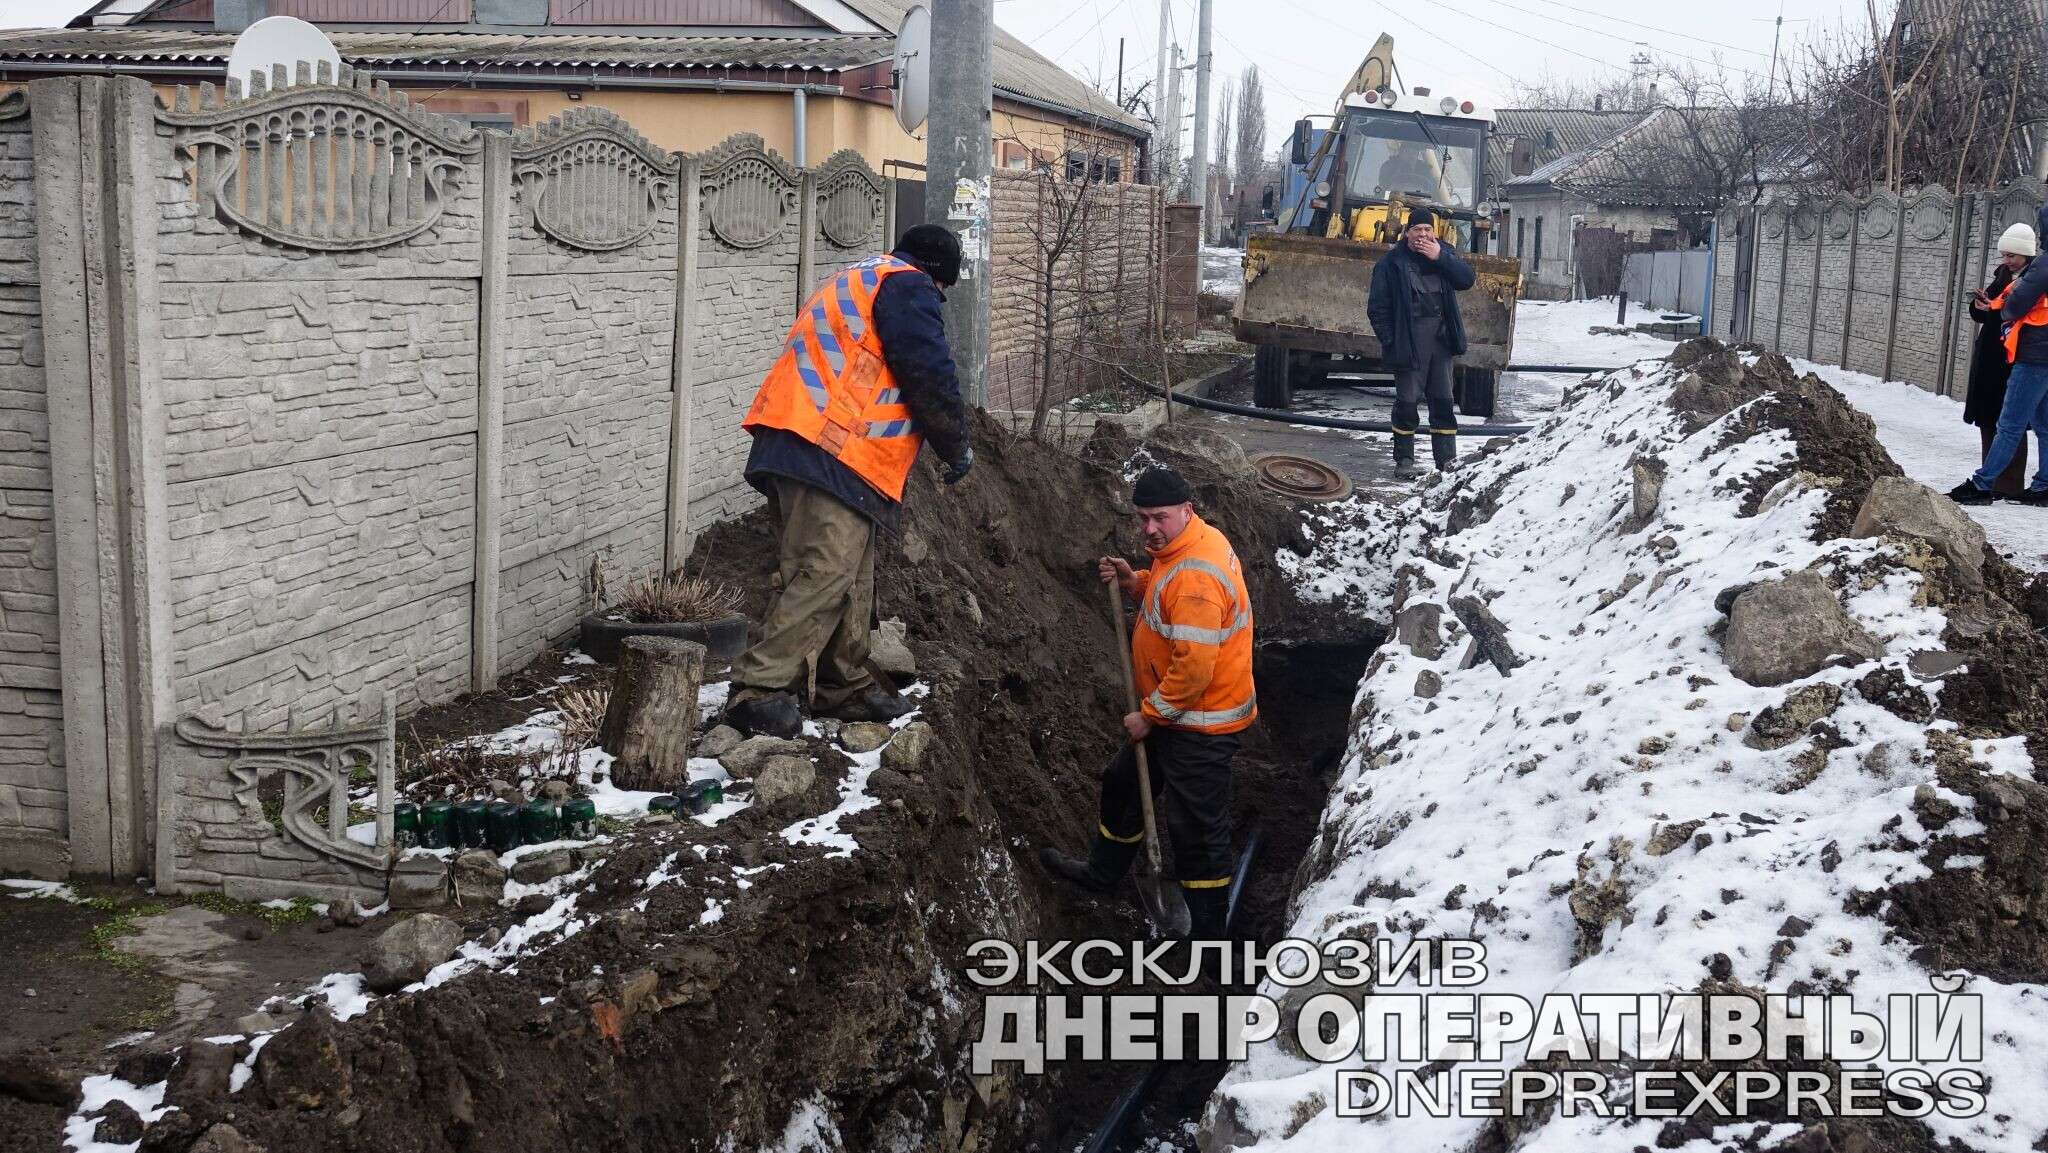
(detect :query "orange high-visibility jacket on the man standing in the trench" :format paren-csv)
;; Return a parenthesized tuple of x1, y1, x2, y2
(1130, 516, 1260, 733)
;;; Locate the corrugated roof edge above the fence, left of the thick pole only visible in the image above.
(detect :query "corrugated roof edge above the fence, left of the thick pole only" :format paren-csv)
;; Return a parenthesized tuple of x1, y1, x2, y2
(0, 27, 895, 72)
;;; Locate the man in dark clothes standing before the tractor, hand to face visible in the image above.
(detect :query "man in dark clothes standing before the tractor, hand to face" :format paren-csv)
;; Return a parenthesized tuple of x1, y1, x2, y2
(1366, 209, 1477, 477)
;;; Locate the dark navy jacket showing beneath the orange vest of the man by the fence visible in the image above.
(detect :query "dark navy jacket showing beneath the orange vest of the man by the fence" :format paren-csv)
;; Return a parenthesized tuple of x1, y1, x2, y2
(745, 252, 967, 532)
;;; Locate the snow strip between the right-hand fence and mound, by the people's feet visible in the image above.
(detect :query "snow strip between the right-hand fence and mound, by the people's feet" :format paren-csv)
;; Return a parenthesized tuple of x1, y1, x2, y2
(1792, 360, 2048, 571)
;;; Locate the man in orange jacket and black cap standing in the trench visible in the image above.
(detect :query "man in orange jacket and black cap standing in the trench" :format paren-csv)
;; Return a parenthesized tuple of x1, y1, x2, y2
(1038, 469, 1260, 940)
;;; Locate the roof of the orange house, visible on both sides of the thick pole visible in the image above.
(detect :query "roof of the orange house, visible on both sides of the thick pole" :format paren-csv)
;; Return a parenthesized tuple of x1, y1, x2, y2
(0, 0, 1151, 135)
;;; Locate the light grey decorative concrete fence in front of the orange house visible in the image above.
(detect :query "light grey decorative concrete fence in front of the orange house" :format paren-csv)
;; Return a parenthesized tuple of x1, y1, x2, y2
(0, 70, 889, 897)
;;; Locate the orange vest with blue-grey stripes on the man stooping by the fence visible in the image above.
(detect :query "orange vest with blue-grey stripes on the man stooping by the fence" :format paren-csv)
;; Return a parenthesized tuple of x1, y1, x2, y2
(739, 256, 924, 500)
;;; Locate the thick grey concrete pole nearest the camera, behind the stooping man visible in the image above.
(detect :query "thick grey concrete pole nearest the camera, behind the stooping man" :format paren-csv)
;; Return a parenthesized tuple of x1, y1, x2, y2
(924, 0, 995, 408)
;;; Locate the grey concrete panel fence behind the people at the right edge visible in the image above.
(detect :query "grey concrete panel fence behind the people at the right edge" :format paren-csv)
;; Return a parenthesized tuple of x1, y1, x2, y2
(1710, 180, 2042, 395)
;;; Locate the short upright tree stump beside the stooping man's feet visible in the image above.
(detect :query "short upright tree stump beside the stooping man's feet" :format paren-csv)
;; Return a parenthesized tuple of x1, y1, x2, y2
(600, 637, 705, 793)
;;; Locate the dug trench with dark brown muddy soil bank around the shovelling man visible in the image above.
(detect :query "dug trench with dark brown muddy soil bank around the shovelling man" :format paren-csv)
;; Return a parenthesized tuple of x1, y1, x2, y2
(112, 409, 1382, 1153)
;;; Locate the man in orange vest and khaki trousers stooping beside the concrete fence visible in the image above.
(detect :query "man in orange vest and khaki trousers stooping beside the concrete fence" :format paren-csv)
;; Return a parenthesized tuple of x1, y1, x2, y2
(725, 225, 975, 737)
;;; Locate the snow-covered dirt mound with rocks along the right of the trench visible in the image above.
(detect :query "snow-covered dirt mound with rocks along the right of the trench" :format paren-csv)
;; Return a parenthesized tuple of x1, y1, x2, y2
(1204, 340, 2048, 1153)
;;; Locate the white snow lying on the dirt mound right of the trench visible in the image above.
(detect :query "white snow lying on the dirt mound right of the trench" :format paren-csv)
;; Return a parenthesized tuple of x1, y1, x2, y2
(1210, 352, 2048, 1153)
